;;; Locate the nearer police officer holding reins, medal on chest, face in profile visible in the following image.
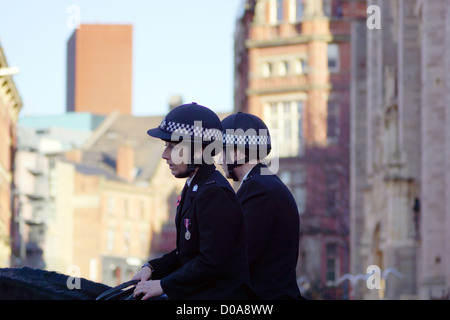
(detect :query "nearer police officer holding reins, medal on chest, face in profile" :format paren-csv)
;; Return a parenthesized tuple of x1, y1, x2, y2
(133, 102, 252, 300)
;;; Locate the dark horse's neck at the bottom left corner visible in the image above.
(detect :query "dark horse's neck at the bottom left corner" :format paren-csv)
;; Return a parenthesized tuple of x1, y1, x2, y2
(0, 267, 112, 300)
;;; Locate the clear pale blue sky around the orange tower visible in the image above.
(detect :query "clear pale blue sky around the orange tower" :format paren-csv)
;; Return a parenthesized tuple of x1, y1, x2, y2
(0, 0, 243, 116)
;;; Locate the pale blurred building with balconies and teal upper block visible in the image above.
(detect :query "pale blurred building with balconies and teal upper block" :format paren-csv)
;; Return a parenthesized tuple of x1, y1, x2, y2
(11, 113, 104, 268)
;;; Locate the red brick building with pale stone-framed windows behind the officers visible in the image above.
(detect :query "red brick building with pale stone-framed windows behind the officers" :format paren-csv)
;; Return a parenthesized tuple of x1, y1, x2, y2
(234, 0, 366, 299)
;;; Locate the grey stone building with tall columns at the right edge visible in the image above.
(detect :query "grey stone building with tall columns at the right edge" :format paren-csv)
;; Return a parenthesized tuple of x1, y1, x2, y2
(350, 0, 450, 299)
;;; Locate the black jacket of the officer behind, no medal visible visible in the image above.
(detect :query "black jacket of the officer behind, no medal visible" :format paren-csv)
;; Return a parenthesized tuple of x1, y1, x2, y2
(237, 163, 302, 300)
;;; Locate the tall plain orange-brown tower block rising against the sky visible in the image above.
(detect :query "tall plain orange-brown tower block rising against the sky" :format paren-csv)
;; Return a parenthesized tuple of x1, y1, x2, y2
(66, 24, 133, 115)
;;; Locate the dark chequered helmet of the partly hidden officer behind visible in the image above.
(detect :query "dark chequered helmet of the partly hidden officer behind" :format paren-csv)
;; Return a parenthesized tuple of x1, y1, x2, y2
(222, 112, 272, 181)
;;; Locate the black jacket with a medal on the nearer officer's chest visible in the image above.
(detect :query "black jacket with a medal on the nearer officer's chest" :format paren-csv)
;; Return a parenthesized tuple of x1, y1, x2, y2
(149, 165, 252, 300)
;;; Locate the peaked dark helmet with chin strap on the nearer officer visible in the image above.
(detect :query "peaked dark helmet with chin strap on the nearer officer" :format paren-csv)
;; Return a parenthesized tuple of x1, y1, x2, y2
(147, 102, 222, 176)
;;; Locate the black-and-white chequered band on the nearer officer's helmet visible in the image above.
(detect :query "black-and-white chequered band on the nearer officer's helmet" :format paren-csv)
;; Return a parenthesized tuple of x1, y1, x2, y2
(159, 118, 222, 141)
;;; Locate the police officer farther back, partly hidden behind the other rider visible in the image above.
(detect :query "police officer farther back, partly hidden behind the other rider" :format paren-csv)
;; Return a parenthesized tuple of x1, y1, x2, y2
(222, 112, 303, 300)
